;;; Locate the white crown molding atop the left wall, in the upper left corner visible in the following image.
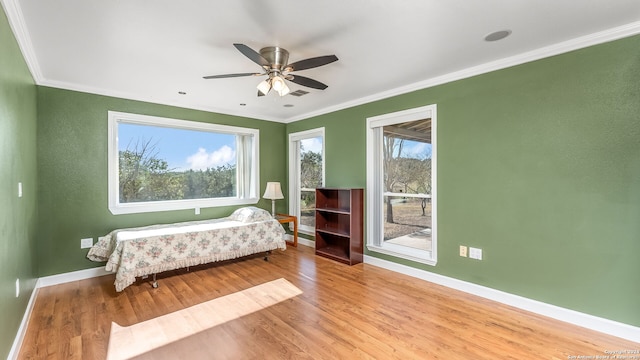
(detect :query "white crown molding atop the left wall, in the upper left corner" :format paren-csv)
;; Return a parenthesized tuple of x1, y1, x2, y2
(0, 0, 44, 84)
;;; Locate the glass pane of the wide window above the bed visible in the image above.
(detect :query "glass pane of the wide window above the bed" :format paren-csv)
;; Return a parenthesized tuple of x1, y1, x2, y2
(118, 123, 237, 203)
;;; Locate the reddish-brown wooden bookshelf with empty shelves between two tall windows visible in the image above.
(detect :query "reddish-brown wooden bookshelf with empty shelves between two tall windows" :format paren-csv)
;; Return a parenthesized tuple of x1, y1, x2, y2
(316, 188, 364, 265)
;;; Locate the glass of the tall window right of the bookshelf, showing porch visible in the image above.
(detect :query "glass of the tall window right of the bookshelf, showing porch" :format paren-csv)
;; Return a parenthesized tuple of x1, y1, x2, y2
(382, 119, 432, 251)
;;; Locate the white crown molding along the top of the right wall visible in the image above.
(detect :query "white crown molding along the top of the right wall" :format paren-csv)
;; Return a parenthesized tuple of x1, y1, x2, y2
(283, 21, 640, 123)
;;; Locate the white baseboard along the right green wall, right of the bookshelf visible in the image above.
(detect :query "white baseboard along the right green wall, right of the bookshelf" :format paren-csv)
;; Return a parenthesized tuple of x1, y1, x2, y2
(364, 255, 640, 343)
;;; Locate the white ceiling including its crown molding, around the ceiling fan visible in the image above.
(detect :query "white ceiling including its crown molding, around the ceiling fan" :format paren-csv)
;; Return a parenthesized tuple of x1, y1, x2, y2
(0, 0, 640, 122)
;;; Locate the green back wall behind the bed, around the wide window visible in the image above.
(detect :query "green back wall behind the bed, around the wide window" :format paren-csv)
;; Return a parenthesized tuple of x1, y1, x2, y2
(38, 87, 286, 276)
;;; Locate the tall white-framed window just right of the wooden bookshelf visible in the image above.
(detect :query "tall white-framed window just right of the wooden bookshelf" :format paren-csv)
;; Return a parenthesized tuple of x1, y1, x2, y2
(367, 105, 437, 265)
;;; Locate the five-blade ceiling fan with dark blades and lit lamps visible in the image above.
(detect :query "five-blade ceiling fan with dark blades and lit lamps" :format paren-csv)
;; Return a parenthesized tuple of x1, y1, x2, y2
(204, 44, 338, 96)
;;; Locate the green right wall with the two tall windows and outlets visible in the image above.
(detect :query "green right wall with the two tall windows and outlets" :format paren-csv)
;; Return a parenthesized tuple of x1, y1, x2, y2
(287, 36, 640, 326)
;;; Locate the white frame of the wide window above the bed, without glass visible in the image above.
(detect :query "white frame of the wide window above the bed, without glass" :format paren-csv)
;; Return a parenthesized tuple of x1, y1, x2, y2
(108, 111, 260, 215)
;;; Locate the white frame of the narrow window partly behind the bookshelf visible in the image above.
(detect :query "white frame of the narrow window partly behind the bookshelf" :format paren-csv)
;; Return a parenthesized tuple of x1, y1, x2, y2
(289, 127, 326, 235)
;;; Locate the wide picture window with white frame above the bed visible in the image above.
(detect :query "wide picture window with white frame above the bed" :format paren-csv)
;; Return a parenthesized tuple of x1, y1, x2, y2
(108, 111, 259, 214)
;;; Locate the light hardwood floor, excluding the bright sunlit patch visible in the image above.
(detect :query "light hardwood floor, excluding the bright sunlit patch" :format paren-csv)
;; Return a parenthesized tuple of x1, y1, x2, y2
(19, 246, 640, 359)
